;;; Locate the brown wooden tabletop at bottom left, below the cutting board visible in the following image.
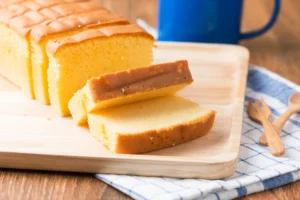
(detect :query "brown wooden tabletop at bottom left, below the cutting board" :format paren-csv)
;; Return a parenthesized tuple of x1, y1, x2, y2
(0, 170, 129, 200)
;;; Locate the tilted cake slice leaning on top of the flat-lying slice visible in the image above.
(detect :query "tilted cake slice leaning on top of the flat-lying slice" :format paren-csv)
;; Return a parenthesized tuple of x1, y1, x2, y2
(69, 60, 193, 125)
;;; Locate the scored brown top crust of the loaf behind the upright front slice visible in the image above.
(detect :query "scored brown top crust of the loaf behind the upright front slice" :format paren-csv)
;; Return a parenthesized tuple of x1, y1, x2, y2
(0, 0, 129, 38)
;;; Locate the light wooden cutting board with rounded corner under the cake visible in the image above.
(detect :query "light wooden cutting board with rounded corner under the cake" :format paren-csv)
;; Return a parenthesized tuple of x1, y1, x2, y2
(0, 43, 249, 179)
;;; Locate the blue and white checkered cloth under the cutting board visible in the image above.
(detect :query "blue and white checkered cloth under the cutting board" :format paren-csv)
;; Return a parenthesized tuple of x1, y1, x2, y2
(96, 67, 300, 200)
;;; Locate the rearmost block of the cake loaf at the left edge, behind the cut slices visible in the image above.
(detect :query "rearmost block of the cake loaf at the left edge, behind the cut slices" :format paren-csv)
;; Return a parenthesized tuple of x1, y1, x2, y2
(0, 0, 105, 98)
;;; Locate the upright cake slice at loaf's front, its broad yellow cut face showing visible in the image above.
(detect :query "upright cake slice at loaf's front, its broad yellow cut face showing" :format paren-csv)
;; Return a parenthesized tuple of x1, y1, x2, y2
(47, 24, 154, 116)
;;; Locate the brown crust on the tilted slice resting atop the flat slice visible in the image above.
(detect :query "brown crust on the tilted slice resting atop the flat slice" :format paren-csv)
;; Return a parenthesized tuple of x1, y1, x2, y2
(88, 60, 193, 103)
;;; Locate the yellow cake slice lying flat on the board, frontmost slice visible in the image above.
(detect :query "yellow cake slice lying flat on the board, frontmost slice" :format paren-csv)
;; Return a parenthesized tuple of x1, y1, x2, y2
(88, 96, 215, 154)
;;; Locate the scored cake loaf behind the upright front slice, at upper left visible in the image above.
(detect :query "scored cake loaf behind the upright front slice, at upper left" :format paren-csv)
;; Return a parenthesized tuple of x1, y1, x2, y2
(0, 0, 129, 104)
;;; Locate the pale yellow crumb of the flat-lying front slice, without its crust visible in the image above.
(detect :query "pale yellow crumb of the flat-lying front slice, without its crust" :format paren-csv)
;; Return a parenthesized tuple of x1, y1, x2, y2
(88, 96, 211, 152)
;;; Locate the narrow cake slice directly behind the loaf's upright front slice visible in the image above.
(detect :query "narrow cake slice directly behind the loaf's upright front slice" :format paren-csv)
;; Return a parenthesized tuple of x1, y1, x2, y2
(30, 0, 129, 105)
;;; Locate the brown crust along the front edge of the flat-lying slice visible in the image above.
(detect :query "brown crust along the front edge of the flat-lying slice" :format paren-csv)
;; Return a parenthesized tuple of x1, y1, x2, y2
(111, 111, 215, 154)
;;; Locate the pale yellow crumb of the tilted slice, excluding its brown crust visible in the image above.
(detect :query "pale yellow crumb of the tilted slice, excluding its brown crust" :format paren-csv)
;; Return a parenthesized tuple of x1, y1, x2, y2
(69, 83, 189, 125)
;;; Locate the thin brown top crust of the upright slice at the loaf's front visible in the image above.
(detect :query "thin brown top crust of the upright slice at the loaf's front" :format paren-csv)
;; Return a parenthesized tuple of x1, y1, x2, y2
(46, 24, 154, 54)
